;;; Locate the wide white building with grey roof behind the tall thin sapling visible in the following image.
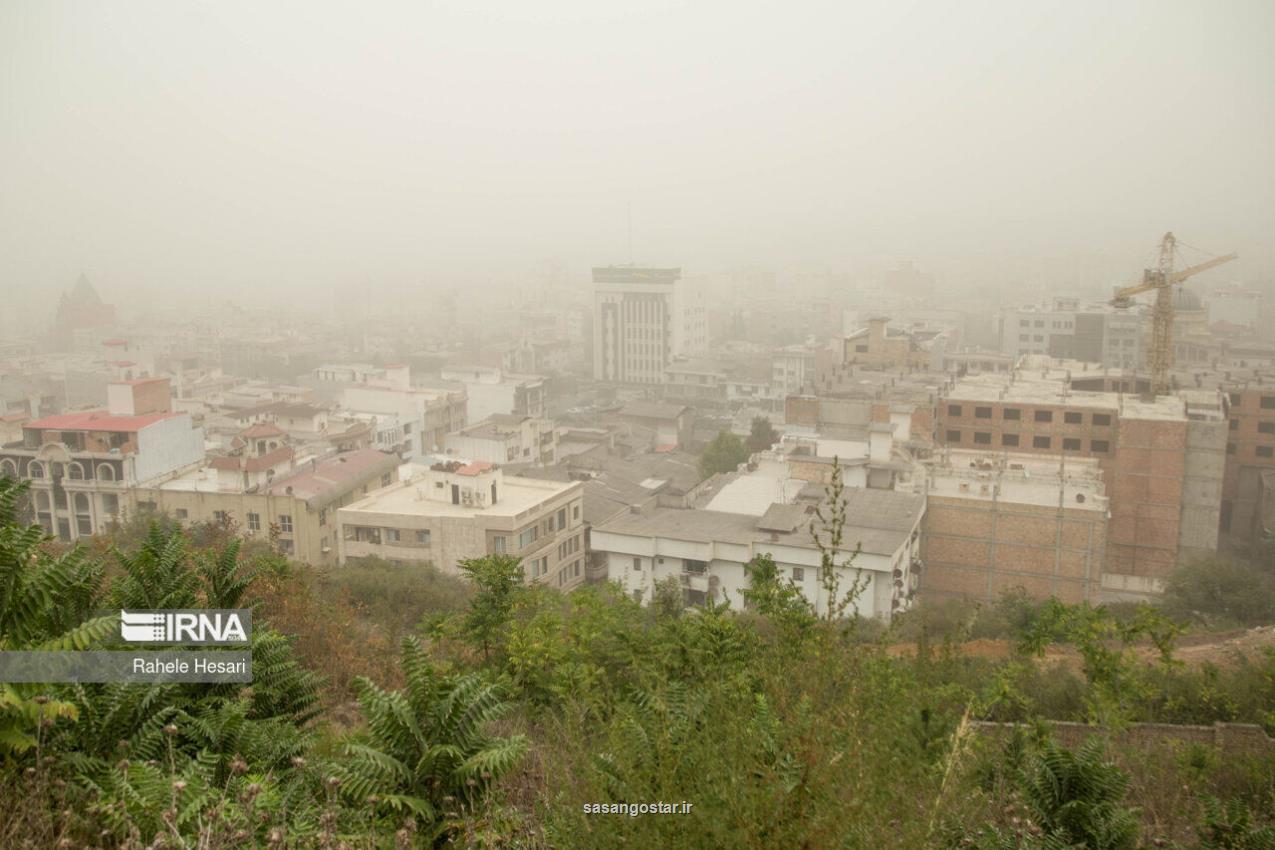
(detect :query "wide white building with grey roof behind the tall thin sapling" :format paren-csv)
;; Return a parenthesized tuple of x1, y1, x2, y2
(590, 488, 926, 619)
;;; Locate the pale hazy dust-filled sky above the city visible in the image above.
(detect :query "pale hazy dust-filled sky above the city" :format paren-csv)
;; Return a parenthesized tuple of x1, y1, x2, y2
(0, 0, 1275, 299)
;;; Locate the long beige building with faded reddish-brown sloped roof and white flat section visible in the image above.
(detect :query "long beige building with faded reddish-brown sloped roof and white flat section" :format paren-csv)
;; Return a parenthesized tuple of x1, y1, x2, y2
(135, 446, 399, 566)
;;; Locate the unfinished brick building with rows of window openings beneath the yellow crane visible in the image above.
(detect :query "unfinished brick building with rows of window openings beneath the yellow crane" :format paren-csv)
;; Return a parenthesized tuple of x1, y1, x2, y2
(936, 357, 1227, 596)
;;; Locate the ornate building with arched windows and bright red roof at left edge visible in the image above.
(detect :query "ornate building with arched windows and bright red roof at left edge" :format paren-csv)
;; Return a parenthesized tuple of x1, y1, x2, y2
(0, 378, 204, 540)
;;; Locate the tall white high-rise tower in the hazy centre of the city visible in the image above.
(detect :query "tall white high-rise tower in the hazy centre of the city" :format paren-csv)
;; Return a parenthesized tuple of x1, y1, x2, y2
(593, 266, 708, 384)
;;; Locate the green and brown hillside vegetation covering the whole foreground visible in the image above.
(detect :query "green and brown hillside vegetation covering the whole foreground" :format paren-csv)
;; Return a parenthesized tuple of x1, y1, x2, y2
(0, 480, 1275, 850)
